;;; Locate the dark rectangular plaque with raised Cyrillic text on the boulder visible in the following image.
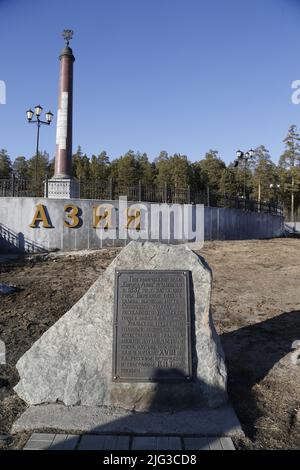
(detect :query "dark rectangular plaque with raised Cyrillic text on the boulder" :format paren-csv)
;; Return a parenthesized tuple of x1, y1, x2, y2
(113, 270, 192, 382)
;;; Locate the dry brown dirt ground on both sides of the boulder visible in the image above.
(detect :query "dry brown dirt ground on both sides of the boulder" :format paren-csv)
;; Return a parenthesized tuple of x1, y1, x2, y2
(0, 239, 300, 449)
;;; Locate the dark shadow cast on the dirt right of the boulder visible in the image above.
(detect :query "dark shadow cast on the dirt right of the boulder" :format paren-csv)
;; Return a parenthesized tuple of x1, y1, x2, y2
(221, 310, 300, 439)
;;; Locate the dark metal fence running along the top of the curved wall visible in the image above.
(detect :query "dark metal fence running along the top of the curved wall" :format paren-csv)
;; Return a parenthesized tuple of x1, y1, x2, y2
(0, 176, 283, 215)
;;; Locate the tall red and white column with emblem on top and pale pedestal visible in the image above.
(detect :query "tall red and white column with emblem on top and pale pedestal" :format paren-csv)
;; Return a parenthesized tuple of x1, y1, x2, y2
(48, 29, 78, 199)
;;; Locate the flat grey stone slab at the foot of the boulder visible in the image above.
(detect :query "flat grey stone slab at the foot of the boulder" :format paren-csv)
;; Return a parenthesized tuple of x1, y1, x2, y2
(12, 404, 244, 437)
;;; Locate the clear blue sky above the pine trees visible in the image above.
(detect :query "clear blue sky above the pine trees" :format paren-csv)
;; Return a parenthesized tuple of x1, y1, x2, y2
(0, 0, 300, 162)
